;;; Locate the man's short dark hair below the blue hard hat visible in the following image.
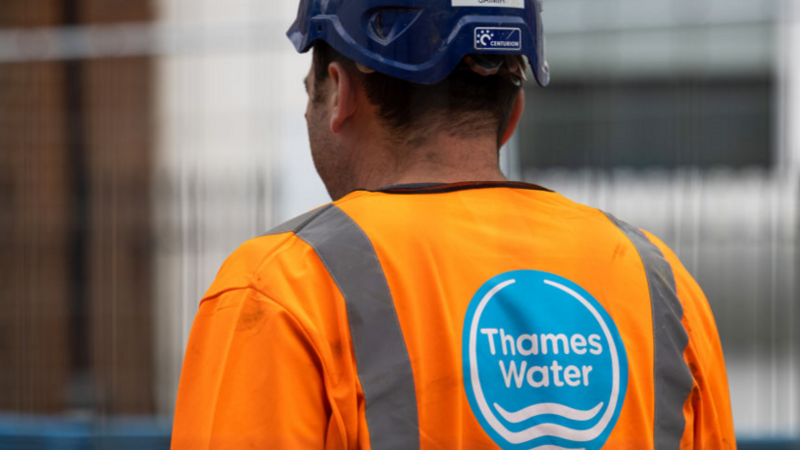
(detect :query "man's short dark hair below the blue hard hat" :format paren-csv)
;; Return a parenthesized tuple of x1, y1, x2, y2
(314, 41, 520, 147)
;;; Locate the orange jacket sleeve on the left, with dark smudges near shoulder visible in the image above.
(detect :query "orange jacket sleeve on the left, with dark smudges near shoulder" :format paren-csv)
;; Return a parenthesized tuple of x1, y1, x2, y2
(172, 289, 331, 450)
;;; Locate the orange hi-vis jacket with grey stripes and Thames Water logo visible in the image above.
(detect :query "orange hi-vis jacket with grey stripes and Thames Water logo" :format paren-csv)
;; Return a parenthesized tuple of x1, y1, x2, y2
(172, 183, 736, 450)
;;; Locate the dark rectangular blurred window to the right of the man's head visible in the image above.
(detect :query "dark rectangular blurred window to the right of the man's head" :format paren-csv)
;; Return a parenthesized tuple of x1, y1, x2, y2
(519, 77, 775, 170)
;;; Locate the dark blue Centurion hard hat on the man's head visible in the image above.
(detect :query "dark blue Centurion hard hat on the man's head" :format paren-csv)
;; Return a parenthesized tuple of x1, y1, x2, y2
(287, 0, 550, 86)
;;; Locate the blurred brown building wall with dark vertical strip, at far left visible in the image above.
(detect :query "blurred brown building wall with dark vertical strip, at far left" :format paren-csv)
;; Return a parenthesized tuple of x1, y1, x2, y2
(0, 0, 154, 414)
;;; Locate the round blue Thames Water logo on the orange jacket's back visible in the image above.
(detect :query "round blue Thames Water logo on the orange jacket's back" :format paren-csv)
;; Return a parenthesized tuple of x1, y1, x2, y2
(463, 270, 628, 450)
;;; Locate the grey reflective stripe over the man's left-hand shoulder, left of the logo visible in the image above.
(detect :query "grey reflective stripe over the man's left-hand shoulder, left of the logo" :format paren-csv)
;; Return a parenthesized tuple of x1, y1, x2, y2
(293, 205, 419, 450)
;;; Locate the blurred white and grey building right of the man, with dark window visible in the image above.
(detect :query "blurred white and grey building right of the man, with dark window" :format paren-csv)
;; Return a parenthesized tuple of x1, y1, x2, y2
(517, 0, 800, 436)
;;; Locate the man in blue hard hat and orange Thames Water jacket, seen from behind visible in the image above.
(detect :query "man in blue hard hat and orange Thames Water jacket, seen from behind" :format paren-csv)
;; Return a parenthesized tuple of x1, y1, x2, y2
(172, 0, 736, 450)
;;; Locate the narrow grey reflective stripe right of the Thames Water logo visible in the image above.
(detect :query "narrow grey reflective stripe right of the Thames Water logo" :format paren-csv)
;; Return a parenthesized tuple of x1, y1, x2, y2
(606, 214, 694, 450)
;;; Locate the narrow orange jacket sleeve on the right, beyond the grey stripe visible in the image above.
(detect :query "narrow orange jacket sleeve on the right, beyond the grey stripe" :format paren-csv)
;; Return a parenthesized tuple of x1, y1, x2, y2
(645, 232, 736, 450)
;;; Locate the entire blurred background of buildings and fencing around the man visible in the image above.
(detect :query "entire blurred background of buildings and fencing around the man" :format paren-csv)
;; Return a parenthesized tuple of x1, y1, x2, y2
(0, 0, 800, 449)
